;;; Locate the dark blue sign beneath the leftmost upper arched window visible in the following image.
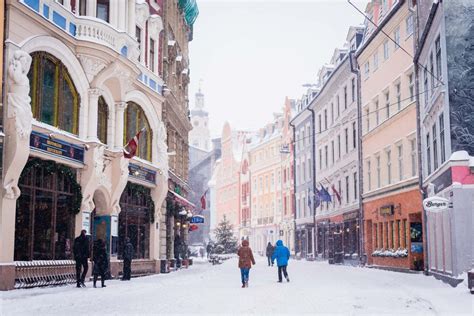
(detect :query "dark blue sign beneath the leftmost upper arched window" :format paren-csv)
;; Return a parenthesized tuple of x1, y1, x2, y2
(30, 131, 84, 163)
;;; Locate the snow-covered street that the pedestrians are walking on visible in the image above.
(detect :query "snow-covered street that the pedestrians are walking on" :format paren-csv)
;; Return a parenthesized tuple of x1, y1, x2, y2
(0, 258, 473, 316)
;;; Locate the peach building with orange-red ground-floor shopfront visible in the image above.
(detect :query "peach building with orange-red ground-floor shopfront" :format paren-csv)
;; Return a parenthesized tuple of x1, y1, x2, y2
(357, 0, 424, 270)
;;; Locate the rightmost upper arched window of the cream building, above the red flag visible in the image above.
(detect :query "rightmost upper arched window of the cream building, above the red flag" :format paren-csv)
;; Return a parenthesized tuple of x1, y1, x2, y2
(123, 102, 151, 161)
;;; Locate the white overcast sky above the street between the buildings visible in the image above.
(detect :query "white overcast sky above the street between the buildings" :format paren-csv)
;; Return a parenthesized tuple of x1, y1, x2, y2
(189, 0, 367, 137)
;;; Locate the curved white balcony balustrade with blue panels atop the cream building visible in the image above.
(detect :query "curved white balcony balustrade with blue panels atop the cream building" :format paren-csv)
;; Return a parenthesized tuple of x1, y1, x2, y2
(19, 0, 139, 62)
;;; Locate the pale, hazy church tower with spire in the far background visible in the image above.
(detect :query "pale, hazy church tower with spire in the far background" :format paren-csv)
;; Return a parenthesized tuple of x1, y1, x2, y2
(189, 87, 212, 151)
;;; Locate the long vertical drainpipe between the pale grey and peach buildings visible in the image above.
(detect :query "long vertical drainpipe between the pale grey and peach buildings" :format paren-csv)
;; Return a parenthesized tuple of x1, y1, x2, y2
(349, 51, 367, 265)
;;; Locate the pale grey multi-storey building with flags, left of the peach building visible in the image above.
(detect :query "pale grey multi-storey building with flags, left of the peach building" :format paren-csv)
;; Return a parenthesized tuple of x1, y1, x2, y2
(310, 27, 364, 263)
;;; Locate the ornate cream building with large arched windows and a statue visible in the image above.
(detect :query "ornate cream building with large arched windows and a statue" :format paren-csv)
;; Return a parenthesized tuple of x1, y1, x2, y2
(0, 0, 181, 289)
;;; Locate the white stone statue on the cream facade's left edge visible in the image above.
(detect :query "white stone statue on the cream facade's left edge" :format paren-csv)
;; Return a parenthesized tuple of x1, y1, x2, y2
(3, 50, 33, 200)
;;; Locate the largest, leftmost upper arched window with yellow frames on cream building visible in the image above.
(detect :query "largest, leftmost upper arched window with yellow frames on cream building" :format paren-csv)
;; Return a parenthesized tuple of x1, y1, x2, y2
(28, 52, 79, 134)
